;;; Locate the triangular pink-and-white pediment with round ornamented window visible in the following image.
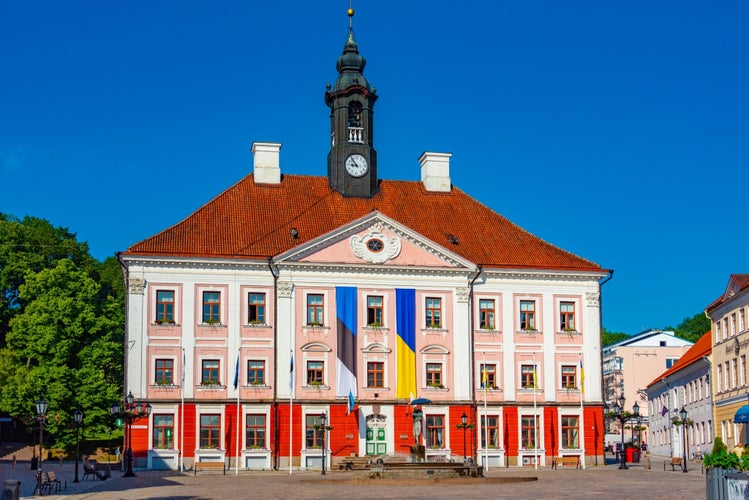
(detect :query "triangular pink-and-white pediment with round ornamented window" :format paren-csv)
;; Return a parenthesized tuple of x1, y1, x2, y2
(274, 211, 476, 269)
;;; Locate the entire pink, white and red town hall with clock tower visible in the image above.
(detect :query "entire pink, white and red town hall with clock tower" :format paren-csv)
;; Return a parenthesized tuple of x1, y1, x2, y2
(119, 9, 610, 468)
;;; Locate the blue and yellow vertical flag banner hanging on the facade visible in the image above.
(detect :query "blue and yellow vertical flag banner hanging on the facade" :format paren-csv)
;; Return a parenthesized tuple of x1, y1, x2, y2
(395, 288, 416, 399)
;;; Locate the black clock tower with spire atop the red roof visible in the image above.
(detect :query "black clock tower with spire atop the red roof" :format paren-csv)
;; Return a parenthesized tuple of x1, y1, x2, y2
(325, 9, 377, 198)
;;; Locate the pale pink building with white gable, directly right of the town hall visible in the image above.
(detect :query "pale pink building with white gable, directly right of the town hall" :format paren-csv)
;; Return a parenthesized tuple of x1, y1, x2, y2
(603, 329, 693, 441)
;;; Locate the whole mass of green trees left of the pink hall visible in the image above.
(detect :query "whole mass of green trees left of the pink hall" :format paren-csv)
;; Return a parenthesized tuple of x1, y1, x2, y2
(0, 214, 125, 446)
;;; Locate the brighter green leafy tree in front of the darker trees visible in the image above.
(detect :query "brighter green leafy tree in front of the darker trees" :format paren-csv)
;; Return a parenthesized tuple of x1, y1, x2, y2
(0, 259, 124, 446)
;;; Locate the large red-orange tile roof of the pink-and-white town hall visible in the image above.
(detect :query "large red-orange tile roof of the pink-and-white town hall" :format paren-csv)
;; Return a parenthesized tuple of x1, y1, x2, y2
(124, 174, 603, 272)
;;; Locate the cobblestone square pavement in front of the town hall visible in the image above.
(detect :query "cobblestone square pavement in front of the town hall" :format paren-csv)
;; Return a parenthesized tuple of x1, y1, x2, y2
(0, 458, 705, 500)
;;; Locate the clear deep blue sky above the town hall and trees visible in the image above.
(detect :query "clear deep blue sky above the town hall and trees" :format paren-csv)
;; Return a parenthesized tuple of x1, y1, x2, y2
(0, 0, 749, 333)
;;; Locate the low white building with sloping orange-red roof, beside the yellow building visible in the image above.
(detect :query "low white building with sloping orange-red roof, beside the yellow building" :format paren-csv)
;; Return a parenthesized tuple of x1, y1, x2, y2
(645, 332, 713, 457)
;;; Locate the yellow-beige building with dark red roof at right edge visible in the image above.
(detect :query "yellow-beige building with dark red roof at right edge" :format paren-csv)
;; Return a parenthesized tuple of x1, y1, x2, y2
(705, 274, 749, 448)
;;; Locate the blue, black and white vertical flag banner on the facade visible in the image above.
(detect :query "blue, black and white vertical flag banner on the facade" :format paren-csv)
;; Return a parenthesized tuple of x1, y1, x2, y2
(335, 286, 358, 397)
